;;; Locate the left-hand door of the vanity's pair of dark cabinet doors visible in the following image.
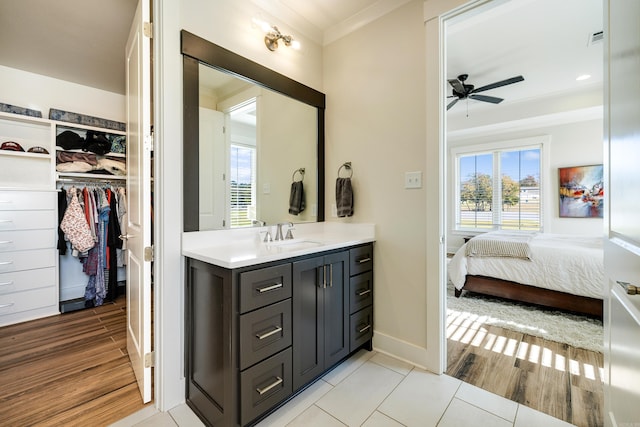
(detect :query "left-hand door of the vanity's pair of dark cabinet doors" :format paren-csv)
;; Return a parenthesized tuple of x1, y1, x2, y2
(292, 257, 324, 391)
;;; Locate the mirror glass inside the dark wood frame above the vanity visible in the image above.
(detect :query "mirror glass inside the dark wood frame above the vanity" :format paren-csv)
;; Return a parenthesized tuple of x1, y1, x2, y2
(198, 65, 318, 230)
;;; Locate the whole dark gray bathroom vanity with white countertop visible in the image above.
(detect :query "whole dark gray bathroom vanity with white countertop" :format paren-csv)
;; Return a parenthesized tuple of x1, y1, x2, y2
(183, 223, 374, 426)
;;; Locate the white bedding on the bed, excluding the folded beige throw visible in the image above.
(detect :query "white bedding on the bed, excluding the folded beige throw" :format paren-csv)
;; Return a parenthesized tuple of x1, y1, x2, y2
(448, 233, 604, 299)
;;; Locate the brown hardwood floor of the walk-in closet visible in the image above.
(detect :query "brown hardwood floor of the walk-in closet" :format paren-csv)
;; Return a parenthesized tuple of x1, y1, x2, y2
(0, 296, 145, 426)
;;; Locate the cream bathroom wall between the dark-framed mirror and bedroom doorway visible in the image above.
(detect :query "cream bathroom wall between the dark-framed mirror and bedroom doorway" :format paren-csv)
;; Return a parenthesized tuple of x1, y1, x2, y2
(323, 0, 431, 366)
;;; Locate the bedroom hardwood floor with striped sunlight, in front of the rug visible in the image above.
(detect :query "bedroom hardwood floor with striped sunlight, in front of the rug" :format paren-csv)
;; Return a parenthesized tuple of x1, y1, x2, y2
(447, 325, 604, 427)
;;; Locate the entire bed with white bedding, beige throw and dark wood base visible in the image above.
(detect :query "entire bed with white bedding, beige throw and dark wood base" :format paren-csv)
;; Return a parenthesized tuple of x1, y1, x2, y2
(448, 231, 604, 318)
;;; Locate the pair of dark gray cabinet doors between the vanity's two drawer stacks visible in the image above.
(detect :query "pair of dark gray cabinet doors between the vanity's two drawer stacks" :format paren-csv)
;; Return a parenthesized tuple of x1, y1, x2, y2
(293, 250, 349, 391)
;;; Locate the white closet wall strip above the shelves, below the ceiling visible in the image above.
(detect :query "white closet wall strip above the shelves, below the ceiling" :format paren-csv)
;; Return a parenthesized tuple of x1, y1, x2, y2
(0, 65, 126, 122)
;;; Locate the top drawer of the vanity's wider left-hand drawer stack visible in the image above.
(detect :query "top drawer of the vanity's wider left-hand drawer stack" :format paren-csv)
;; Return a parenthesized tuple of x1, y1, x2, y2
(240, 263, 291, 313)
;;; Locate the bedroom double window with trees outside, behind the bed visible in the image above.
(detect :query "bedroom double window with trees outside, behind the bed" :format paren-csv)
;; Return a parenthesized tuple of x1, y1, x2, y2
(453, 141, 542, 231)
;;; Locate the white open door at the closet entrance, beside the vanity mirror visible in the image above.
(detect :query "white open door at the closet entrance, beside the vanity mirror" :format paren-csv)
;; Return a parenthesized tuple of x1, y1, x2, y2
(126, 0, 152, 403)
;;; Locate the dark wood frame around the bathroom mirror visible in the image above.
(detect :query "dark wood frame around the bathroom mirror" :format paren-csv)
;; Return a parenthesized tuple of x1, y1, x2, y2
(180, 30, 326, 231)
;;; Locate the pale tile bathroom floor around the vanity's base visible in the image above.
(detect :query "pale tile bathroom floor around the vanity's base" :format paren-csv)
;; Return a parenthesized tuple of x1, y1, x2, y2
(113, 351, 571, 427)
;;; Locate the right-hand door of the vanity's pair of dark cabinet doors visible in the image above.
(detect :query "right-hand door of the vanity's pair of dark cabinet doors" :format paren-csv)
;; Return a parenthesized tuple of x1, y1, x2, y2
(323, 251, 349, 368)
